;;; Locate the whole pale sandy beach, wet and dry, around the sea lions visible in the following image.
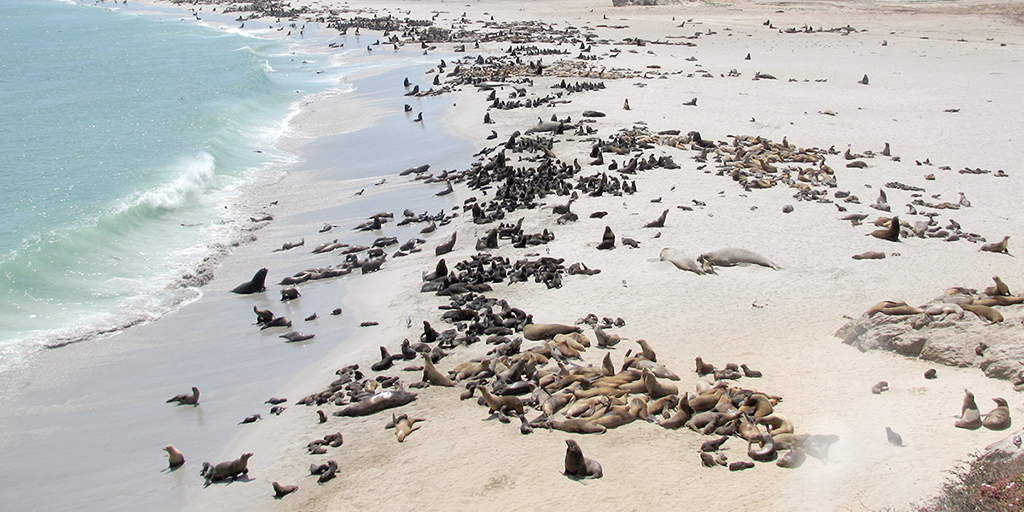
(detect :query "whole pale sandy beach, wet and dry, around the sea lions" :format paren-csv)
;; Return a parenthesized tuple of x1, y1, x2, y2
(4, 0, 1024, 511)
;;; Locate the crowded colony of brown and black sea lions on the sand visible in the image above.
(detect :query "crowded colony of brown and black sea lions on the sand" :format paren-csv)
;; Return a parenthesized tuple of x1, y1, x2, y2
(159, 2, 1009, 499)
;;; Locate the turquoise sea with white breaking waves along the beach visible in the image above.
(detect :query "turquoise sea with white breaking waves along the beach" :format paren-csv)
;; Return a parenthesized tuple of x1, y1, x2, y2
(0, 0, 343, 371)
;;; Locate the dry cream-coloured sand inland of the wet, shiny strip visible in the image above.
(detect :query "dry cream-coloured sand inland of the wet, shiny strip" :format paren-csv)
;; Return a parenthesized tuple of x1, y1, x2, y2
(180, 1, 1024, 510)
